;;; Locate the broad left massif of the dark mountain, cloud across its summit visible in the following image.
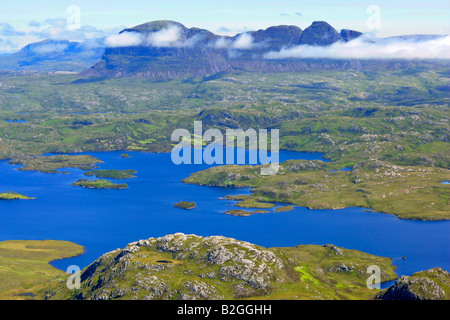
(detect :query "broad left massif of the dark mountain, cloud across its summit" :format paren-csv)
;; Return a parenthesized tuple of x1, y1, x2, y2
(84, 21, 229, 80)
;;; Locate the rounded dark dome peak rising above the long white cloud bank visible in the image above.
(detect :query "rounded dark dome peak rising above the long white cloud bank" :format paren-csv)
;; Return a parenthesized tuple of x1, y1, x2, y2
(298, 21, 342, 46)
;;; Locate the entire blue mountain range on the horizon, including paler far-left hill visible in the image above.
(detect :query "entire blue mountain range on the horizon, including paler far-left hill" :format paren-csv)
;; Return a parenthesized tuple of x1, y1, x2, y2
(0, 20, 444, 81)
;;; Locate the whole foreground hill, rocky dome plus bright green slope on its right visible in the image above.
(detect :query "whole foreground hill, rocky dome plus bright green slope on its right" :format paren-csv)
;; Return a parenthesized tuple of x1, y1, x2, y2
(41, 233, 397, 300)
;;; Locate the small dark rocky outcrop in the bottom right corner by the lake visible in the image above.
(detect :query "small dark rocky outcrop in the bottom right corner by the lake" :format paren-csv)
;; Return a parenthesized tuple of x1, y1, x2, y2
(377, 268, 450, 300)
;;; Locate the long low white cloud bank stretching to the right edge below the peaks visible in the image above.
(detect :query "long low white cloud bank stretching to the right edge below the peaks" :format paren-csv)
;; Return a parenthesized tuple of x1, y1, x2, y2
(264, 36, 450, 59)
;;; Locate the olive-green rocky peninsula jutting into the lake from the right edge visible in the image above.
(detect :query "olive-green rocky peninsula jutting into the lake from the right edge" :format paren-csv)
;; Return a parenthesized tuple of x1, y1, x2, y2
(183, 160, 450, 220)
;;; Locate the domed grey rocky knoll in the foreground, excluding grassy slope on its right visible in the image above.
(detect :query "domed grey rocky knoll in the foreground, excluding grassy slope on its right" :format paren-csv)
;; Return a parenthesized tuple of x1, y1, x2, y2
(53, 233, 287, 300)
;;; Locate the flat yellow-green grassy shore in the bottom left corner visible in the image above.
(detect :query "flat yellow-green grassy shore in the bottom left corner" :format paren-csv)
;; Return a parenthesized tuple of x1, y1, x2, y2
(0, 240, 84, 300)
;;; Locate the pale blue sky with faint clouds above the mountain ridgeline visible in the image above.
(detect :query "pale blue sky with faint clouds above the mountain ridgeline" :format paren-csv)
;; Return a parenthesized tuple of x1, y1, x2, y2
(0, 0, 450, 53)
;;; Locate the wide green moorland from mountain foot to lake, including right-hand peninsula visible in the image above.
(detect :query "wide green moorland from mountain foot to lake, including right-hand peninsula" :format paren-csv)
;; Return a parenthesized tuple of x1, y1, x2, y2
(0, 69, 450, 220)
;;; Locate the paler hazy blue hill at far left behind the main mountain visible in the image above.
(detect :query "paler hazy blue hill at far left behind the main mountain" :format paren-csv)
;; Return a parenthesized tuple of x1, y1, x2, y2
(0, 40, 104, 72)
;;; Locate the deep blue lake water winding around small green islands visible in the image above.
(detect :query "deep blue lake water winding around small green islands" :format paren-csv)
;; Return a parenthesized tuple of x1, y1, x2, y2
(0, 151, 450, 282)
